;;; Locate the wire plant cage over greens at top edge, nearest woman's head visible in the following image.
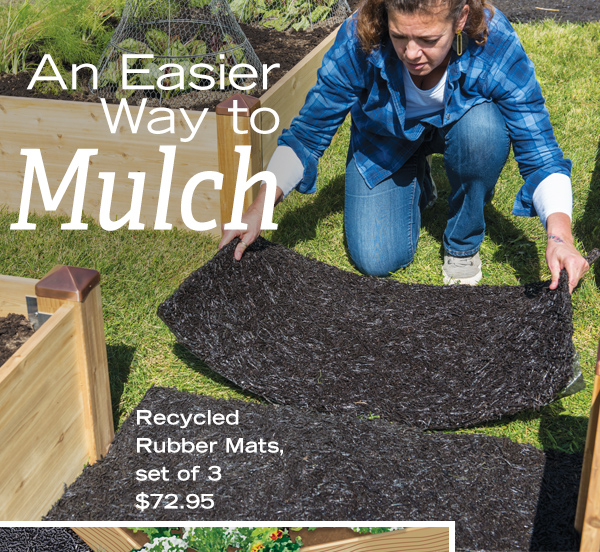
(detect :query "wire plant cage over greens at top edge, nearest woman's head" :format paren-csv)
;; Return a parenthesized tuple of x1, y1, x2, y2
(230, 0, 351, 31)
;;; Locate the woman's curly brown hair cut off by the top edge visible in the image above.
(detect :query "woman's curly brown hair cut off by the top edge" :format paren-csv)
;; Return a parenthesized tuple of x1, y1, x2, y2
(356, 0, 494, 53)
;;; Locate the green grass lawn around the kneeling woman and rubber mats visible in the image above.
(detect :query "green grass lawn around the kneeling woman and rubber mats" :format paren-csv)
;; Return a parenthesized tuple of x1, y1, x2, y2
(0, 22, 600, 451)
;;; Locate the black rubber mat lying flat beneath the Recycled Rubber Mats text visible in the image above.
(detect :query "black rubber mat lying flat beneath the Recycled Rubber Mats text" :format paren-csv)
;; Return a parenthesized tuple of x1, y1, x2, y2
(46, 388, 581, 550)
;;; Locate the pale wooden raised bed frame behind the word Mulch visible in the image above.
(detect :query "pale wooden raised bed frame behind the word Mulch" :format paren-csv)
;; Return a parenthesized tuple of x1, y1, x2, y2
(0, 24, 337, 236)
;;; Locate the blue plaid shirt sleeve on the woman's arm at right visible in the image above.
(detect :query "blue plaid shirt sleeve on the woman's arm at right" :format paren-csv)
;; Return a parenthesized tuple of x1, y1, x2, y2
(483, 16, 571, 216)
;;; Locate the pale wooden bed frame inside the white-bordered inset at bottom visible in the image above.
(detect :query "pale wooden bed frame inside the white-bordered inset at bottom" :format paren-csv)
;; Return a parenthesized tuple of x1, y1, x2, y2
(72, 527, 450, 552)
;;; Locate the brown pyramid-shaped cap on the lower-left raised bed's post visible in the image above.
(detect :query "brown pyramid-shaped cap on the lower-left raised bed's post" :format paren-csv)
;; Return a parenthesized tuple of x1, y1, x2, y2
(35, 265, 100, 303)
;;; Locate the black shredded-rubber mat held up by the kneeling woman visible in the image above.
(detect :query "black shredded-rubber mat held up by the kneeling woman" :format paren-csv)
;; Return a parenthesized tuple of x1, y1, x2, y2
(159, 238, 575, 429)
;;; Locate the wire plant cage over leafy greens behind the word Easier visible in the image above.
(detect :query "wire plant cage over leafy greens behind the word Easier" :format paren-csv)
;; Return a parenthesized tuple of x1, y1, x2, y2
(91, 0, 262, 108)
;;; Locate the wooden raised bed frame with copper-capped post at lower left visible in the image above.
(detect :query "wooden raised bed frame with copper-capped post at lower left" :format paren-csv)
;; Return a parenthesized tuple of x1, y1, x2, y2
(0, 267, 114, 521)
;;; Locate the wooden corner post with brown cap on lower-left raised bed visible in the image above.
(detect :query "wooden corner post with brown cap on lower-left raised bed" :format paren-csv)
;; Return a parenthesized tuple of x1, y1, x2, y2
(35, 266, 114, 463)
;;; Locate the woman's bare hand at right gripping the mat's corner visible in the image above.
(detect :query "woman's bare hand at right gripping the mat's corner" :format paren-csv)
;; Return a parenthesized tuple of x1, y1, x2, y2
(546, 213, 590, 293)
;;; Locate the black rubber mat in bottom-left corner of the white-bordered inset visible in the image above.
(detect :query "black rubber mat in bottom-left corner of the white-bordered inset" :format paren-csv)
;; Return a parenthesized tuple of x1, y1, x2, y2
(0, 527, 92, 552)
